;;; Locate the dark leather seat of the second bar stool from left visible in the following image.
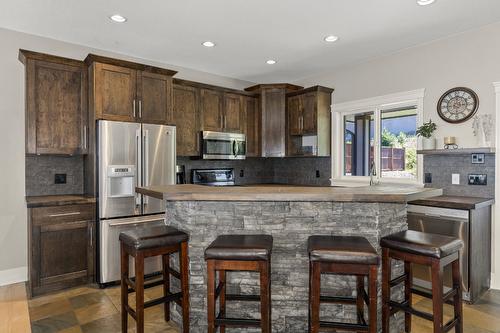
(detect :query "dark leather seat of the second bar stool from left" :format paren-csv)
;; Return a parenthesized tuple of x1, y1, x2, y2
(205, 235, 273, 260)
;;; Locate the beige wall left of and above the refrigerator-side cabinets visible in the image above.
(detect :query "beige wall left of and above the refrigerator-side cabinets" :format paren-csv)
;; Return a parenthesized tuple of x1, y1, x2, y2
(0, 29, 253, 285)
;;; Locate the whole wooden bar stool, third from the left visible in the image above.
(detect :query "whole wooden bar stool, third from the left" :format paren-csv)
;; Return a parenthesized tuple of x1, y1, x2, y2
(307, 236, 379, 333)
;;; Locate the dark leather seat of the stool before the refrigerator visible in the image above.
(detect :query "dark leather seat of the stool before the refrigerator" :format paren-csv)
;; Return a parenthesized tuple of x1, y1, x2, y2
(120, 225, 189, 250)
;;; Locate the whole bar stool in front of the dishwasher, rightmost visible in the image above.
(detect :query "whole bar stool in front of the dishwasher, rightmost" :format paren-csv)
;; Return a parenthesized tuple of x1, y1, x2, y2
(380, 231, 463, 333)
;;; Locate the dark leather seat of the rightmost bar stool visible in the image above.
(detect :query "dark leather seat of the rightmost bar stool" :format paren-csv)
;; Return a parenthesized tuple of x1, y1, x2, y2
(380, 230, 464, 258)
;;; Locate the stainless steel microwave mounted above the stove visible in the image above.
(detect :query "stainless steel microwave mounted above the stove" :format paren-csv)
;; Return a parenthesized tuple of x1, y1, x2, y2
(201, 131, 246, 160)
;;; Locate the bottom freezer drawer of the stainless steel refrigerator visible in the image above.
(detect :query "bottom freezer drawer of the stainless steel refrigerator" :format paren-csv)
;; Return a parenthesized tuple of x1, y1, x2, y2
(99, 214, 165, 283)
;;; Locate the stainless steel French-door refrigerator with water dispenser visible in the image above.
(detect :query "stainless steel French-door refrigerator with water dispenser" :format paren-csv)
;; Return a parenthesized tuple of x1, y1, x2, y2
(97, 120, 176, 283)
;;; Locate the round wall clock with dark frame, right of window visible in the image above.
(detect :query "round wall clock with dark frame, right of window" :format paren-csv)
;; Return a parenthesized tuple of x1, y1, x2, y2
(437, 87, 479, 124)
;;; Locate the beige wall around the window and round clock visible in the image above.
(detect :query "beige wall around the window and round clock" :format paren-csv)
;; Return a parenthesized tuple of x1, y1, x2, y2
(294, 23, 500, 289)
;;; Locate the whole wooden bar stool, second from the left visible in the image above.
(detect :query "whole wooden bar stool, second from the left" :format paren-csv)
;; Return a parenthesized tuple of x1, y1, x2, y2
(205, 235, 273, 333)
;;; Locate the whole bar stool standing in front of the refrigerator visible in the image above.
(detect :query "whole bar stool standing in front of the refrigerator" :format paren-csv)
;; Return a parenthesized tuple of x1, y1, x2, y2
(120, 225, 189, 333)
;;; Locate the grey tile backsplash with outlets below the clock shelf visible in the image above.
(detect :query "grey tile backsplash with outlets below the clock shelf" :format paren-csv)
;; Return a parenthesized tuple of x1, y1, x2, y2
(424, 154, 495, 198)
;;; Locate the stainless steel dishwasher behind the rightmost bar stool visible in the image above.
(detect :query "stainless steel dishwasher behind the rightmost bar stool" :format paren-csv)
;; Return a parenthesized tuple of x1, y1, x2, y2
(408, 205, 471, 301)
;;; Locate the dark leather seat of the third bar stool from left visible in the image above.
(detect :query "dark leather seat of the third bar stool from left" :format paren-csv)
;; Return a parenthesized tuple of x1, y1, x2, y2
(307, 236, 379, 265)
